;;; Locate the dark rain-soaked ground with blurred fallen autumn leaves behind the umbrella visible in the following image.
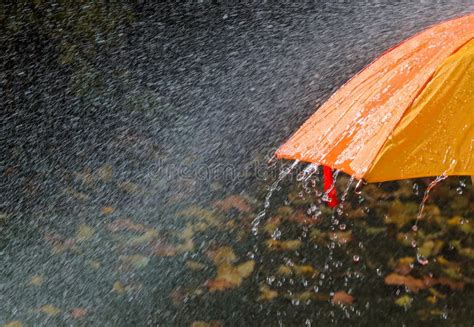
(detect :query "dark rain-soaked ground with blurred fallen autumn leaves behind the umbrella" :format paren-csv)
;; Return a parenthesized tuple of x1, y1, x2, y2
(0, 1, 474, 327)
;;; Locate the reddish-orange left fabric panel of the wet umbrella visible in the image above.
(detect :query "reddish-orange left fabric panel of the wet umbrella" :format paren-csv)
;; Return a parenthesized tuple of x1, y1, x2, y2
(276, 14, 474, 179)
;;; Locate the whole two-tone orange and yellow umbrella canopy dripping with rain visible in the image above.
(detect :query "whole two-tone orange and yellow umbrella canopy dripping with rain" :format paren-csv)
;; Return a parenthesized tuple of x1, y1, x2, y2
(276, 14, 474, 182)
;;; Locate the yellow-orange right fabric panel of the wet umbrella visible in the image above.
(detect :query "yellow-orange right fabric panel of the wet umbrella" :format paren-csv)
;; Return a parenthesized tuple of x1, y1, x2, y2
(365, 40, 474, 182)
